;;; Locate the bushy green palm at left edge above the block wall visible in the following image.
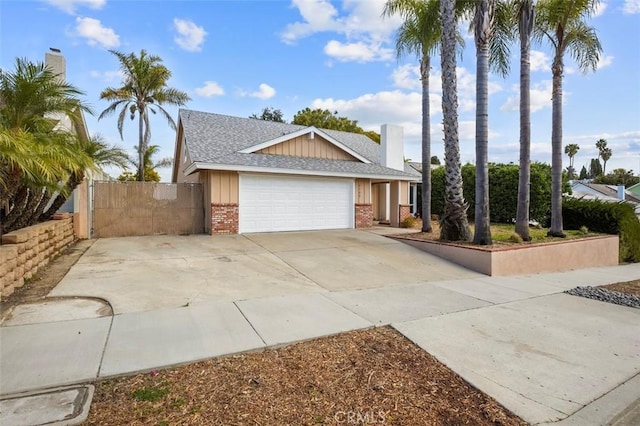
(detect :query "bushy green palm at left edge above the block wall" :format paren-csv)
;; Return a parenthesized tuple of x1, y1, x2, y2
(0, 59, 91, 232)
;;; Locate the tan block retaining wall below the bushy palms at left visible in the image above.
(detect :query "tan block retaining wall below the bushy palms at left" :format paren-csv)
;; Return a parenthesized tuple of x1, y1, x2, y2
(0, 213, 75, 299)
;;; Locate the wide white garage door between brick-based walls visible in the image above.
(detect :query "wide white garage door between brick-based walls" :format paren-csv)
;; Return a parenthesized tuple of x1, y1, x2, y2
(239, 174, 354, 233)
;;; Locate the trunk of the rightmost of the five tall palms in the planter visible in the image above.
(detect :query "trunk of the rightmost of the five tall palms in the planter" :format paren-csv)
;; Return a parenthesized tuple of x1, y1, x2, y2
(548, 54, 566, 237)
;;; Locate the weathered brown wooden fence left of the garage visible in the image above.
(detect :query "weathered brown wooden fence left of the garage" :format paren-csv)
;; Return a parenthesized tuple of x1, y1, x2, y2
(92, 181, 204, 238)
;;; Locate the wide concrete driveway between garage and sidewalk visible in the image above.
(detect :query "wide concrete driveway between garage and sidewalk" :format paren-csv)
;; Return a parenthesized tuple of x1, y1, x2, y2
(50, 230, 483, 314)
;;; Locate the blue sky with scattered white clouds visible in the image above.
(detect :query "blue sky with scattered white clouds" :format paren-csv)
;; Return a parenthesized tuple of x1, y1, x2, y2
(0, 0, 640, 181)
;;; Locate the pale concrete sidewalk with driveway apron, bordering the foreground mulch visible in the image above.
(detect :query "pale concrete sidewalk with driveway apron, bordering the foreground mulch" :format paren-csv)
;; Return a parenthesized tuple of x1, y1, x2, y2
(0, 264, 640, 424)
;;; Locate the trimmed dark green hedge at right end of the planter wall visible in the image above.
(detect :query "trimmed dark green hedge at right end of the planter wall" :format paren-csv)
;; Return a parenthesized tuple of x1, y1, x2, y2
(562, 198, 640, 262)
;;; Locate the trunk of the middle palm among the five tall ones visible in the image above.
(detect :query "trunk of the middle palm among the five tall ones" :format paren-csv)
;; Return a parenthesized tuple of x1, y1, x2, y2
(473, 0, 493, 245)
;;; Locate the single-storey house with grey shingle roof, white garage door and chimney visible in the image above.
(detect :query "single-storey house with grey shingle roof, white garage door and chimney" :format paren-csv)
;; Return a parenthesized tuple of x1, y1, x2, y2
(172, 110, 420, 234)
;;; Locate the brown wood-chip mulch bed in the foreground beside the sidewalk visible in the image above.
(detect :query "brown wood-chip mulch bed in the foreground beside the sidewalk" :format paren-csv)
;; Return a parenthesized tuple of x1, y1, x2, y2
(87, 327, 526, 425)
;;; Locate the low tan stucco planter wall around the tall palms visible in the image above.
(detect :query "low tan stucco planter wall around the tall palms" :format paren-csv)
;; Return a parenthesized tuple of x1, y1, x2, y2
(399, 235, 619, 276)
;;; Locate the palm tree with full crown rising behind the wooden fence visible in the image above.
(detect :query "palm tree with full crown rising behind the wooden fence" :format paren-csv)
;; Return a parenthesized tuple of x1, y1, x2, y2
(98, 49, 190, 181)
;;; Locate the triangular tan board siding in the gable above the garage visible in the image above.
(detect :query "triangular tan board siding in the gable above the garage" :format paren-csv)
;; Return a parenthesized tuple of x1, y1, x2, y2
(257, 134, 357, 161)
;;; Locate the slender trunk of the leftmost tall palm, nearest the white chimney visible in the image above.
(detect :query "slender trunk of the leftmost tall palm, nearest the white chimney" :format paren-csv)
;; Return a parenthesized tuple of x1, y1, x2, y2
(420, 52, 433, 232)
